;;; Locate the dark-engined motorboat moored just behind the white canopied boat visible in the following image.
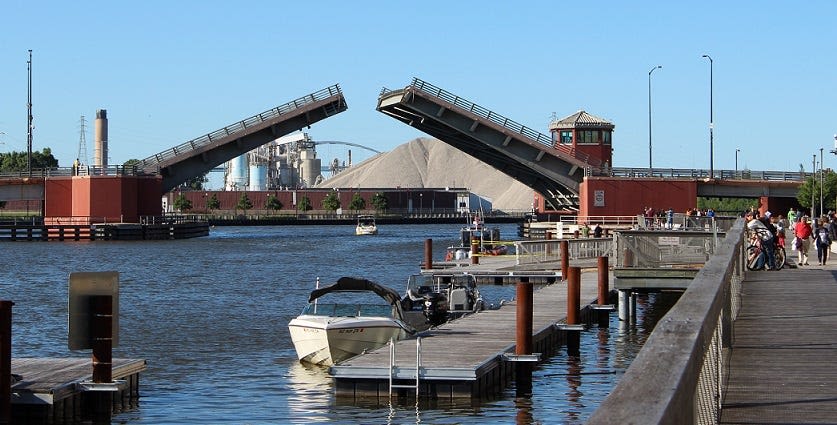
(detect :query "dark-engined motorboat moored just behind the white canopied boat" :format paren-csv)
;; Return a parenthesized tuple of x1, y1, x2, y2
(402, 273, 485, 326)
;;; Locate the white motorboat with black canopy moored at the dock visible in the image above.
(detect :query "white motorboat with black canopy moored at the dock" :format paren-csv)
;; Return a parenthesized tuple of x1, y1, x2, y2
(288, 277, 415, 366)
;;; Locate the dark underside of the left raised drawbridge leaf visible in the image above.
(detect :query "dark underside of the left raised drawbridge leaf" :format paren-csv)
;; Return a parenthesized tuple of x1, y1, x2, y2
(146, 93, 346, 193)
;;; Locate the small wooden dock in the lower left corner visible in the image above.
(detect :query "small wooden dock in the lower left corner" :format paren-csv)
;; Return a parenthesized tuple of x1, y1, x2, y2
(12, 358, 146, 424)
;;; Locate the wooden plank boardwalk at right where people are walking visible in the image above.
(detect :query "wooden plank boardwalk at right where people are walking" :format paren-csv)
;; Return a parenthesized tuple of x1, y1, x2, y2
(720, 264, 837, 424)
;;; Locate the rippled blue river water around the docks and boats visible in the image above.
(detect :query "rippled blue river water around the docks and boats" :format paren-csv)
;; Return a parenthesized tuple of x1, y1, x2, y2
(0, 224, 672, 424)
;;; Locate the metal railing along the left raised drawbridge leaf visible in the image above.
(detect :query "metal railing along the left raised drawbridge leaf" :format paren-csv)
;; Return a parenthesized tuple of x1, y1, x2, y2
(140, 84, 342, 170)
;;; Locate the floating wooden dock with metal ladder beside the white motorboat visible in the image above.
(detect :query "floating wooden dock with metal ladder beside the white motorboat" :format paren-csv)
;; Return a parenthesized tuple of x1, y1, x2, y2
(330, 270, 606, 399)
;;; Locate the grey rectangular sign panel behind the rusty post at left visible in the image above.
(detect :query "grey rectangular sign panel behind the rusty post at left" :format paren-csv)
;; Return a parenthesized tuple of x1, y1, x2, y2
(67, 272, 119, 350)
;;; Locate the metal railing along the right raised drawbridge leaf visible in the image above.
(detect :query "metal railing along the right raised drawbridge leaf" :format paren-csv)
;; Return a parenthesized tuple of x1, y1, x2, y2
(394, 78, 601, 167)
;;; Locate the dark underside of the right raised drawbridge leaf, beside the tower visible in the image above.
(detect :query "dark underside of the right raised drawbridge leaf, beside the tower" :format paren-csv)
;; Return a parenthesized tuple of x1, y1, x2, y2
(378, 90, 584, 208)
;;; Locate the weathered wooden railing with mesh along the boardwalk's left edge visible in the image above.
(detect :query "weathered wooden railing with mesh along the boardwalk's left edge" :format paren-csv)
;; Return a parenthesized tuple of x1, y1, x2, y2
(587, 219, 745, 425)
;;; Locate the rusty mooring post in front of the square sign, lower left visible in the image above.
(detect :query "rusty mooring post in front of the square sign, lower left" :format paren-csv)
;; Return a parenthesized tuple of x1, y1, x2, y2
(90, 295, 113, 422)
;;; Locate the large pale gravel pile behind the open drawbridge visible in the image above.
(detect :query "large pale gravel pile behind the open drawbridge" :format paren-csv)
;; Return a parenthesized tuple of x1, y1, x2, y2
(317, 137, 534, 211)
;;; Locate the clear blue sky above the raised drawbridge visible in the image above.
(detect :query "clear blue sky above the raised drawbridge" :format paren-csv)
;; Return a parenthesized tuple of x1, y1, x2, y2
(0, 0, 837, 187)
